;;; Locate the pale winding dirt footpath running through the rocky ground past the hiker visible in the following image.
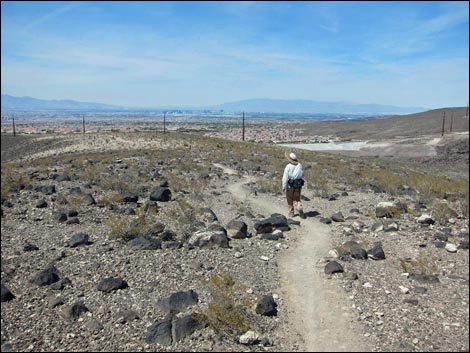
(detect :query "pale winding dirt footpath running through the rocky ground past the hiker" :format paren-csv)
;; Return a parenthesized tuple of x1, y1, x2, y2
(217, 165, 370, 352)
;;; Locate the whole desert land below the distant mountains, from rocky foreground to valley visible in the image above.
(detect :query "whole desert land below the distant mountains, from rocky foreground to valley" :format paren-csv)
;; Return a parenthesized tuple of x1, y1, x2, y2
(1, 108, 469, 351)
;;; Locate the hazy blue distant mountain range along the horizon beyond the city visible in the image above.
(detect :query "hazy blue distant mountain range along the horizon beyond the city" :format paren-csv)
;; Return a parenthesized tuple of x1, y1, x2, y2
(1, 94, 427, 115)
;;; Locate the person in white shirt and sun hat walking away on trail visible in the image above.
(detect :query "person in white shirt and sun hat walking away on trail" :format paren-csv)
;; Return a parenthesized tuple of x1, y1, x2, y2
(282, 152, 306, 219)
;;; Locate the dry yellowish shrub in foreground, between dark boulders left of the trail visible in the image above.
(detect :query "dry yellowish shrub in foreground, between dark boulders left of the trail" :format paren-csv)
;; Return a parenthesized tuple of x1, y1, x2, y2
(205, 272, 254, 338)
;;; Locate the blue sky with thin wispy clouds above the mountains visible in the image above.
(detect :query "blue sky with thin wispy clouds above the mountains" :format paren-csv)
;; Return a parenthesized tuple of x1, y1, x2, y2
(1, 1, 469, 108)
